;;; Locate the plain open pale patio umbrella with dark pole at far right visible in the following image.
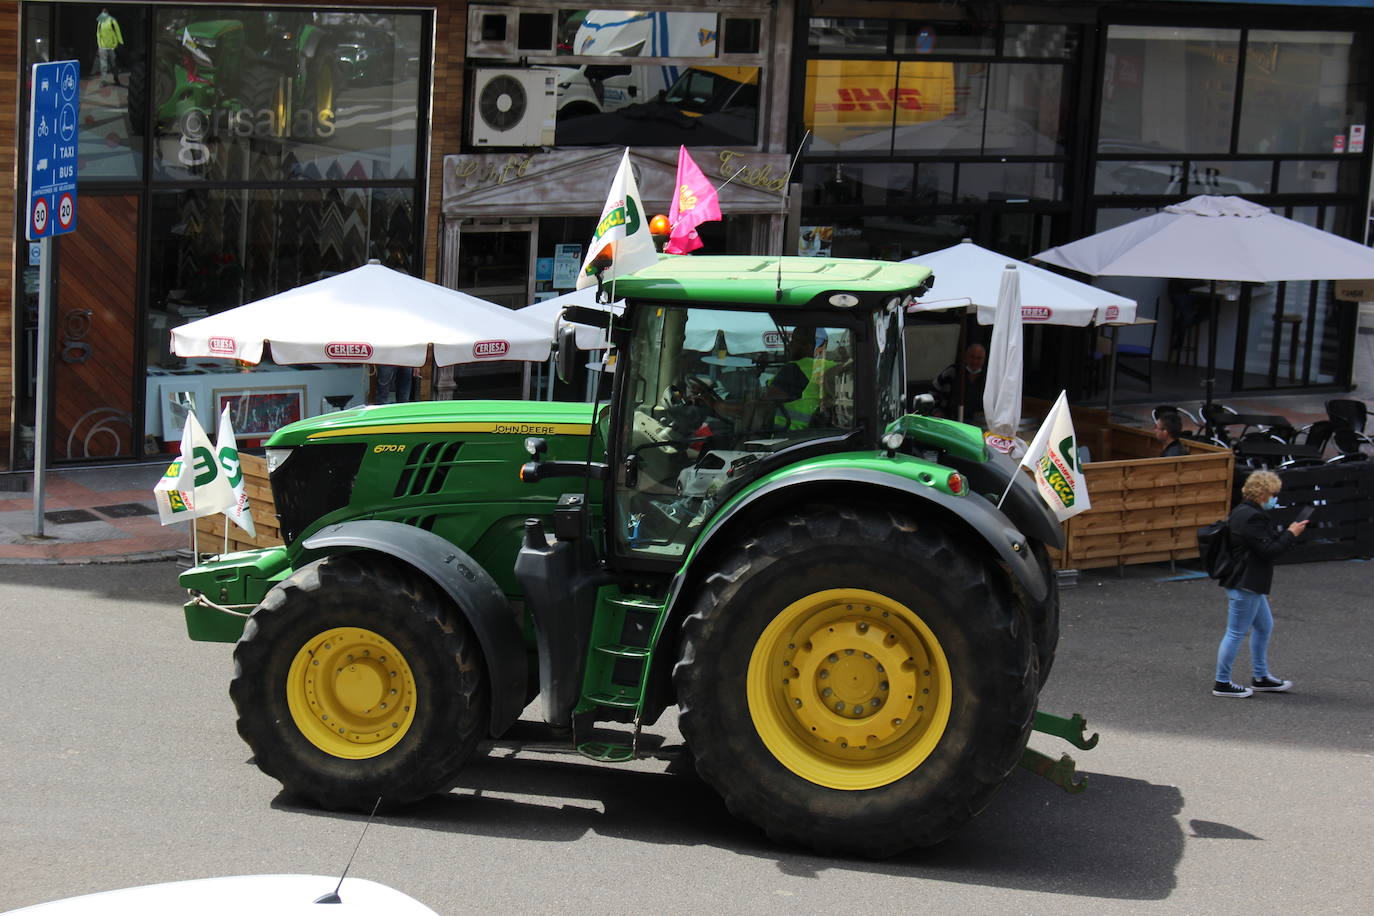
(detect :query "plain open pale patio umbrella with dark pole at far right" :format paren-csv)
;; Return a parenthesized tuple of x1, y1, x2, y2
(1035, 195, 1374, 402)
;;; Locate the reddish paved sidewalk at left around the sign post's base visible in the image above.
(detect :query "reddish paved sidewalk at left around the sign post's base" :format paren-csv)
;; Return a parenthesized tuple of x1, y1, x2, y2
(0, 460, 191, 566)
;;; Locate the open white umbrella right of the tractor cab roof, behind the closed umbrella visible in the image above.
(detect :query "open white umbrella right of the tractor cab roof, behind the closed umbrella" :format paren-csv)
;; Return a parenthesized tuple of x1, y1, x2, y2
(905, 239, 1135, 327)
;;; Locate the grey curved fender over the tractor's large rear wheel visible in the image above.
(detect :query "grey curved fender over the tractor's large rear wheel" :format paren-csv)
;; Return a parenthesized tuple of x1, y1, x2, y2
(669, 467, 1050, 610)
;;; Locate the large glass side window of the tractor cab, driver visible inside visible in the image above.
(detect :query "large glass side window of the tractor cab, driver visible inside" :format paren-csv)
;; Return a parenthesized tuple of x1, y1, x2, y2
(616, 306, 856, 558)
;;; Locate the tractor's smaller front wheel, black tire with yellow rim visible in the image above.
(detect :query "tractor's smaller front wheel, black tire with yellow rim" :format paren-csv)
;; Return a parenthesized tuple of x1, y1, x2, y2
(229, 553, 489, 812)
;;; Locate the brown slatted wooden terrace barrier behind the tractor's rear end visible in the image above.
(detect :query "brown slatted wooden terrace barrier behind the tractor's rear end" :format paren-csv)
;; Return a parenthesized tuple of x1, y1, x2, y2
(1028, 402, 1235, 570)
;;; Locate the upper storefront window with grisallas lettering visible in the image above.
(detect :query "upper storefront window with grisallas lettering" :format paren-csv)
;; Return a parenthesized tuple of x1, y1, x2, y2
(148, 7, 422, 181)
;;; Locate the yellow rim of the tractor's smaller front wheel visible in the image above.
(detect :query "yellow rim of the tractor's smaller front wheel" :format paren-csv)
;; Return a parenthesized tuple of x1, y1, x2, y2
(286, 626, 415, 759)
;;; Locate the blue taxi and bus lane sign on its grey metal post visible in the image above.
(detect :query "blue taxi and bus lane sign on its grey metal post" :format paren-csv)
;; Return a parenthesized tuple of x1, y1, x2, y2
(25, 60, 81, 537)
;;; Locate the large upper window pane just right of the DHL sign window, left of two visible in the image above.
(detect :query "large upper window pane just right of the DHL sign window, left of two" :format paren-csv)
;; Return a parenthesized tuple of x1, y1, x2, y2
(1098, 25, 1241, 152)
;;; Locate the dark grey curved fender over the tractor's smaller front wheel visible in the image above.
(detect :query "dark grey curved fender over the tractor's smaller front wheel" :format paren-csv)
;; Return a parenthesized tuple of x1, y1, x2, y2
(301, 519, 528, 736)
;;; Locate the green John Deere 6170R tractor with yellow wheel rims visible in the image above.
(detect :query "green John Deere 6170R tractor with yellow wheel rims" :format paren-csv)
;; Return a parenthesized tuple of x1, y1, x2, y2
(181, 257, 1091, 856)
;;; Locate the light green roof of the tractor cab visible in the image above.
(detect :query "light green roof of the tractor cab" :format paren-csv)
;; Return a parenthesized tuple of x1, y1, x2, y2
(614, 255, 934, 309)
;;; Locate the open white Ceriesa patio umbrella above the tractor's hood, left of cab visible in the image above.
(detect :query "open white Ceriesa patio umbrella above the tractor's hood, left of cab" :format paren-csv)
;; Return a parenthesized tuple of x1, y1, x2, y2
(172, 264, 552, 365)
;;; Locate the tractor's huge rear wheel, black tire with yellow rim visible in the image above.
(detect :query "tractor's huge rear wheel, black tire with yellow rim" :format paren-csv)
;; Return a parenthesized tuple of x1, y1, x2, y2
(673, 505, 1036, 857)
